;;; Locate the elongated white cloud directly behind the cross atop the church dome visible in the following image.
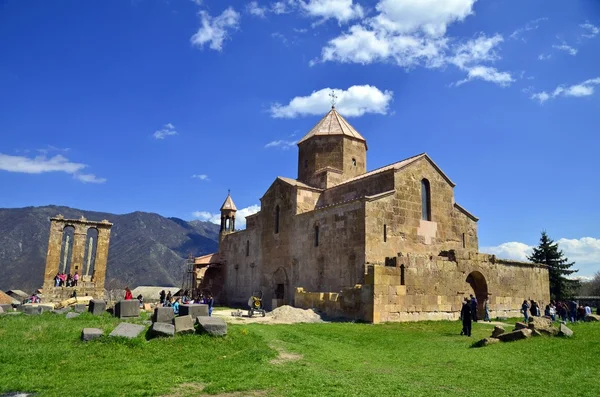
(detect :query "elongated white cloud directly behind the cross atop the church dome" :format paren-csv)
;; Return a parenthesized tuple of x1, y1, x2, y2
(271, 85, 393, 118)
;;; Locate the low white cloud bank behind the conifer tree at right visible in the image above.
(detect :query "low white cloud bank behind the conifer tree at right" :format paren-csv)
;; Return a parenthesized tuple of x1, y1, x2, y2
(480, 237, 600, 276)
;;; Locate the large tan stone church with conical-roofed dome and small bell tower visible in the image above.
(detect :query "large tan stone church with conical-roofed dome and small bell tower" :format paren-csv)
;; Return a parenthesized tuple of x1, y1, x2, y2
(196, 107, 549, 323)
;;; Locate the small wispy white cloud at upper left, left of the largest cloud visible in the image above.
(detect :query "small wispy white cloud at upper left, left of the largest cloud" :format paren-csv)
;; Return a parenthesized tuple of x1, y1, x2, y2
(190, 7, 240, 51)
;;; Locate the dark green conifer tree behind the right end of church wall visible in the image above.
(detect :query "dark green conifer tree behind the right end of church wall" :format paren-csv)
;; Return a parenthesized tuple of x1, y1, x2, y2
(527, 231, 579, 300)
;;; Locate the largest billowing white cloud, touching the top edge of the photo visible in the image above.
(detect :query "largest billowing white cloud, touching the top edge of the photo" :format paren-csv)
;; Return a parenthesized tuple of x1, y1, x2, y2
(311, 0, 514, 86)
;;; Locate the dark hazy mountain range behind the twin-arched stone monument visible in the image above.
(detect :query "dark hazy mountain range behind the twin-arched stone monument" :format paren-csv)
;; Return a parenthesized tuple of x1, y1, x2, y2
(0, 205, 219, 292)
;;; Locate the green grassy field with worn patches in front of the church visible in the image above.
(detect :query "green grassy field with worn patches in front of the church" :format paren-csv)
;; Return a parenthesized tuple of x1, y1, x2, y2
(0, 313, 600, 396)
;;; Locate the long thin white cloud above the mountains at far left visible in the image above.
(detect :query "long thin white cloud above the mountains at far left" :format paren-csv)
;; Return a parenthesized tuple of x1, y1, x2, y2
(0, 153, 106, 183)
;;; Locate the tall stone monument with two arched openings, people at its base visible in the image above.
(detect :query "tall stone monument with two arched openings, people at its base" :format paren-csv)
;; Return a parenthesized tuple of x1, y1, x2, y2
(43, 214, 112, 301)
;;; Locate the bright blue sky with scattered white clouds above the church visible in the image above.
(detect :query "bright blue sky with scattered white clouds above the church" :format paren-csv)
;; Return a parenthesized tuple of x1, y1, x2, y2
(0, 0, 600, 275)
